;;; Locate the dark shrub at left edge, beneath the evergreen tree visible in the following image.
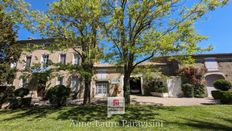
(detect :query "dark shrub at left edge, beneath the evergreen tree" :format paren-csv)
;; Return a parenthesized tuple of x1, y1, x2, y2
(0, 86, 15, 108)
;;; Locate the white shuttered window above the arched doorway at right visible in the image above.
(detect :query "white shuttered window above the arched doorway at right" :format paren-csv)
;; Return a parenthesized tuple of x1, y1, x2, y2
(205, 58, 218, 72)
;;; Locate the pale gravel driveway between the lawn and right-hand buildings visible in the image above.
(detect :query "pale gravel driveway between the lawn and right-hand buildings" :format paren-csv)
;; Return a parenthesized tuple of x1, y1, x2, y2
(131, 95, 218, 106)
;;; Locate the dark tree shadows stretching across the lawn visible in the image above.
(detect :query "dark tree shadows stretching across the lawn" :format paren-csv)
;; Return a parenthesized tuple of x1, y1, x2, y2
(0, 105, 232, 130)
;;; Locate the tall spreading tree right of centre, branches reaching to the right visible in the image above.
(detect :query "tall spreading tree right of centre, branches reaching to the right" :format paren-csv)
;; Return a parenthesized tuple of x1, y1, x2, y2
(103, 0, 228, 104)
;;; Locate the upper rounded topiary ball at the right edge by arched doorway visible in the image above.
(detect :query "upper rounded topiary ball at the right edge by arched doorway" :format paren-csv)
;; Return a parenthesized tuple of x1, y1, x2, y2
(213, 80, 231, 91)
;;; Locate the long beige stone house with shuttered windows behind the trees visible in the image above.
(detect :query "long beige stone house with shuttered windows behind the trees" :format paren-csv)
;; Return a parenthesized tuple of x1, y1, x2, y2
(12, 40, 232, 98)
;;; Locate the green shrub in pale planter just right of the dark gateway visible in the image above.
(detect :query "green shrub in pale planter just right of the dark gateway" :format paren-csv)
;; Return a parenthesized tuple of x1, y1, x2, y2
(151, 82, 168, 97)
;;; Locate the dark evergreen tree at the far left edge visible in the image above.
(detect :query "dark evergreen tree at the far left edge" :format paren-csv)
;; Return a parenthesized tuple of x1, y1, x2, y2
(0, 6, 19, 85)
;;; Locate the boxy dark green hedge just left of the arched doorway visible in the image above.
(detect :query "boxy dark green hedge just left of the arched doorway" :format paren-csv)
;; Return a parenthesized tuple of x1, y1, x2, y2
(182, 83, 206, 98)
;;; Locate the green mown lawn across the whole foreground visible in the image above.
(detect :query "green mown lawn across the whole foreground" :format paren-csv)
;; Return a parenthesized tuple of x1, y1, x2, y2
(0, 105, 232, 131)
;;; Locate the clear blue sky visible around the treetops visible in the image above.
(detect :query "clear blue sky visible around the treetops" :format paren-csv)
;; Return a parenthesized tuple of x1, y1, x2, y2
(18, 0, 232, 53)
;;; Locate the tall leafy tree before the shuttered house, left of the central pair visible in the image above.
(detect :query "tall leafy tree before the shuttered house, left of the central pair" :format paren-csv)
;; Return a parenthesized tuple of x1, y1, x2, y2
(36, 0, 101, 104)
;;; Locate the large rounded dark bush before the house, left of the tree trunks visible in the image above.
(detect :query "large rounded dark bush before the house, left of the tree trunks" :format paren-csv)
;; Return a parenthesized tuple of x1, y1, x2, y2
(45, 85, 70, 107)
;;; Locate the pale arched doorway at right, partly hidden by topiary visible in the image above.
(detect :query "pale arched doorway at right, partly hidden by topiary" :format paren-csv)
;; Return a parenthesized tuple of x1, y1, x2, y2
(205, 73, 225, 97)
